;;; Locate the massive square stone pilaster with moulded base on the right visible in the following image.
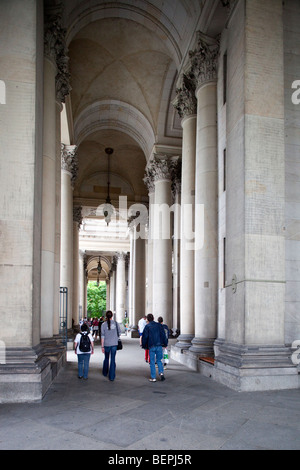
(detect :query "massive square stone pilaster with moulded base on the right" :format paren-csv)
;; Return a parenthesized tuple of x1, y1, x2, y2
(215, 0, 299, 390)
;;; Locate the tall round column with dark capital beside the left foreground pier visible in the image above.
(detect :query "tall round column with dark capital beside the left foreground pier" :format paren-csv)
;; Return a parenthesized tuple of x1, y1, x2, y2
(41, 5, 70, 339)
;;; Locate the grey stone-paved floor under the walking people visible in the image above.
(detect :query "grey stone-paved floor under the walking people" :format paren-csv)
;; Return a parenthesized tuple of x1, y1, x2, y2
(0, 337, 300, 451)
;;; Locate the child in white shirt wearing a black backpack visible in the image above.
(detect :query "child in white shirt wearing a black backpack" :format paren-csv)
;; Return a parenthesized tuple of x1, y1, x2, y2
(74, 323, 94, 380)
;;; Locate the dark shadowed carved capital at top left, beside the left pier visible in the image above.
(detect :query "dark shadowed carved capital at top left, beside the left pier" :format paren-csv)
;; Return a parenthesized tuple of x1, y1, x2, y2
(44, 6, 71, 103)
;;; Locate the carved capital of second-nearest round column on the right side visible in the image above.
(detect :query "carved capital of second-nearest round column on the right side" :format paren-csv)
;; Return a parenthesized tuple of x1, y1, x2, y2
(172, 74, 197, 118)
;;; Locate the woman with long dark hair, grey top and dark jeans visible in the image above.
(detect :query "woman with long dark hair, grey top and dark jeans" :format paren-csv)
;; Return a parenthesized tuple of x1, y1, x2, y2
(101, 310, 121, 381)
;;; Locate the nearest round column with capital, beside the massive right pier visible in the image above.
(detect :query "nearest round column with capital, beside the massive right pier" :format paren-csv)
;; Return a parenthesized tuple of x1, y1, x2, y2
(190, 33, 219, 356)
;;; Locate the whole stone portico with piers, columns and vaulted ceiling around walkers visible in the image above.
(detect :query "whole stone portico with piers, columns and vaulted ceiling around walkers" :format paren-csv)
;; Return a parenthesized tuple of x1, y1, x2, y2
(0, 0, 300, 403)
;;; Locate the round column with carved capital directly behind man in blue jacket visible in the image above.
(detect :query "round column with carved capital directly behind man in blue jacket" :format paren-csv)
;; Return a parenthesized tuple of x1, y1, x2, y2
(151, 155, 172, 325)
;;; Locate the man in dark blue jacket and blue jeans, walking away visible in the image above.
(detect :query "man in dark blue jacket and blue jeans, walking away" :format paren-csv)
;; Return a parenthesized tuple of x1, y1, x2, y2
(142, 313, 168, 382)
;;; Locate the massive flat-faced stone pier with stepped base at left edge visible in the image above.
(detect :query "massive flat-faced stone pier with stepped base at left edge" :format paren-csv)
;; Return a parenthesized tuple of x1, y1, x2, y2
(0, 0, 52, 403)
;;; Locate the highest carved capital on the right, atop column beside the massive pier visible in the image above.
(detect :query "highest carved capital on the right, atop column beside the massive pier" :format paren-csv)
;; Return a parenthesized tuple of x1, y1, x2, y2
(189, 31, 220, 88)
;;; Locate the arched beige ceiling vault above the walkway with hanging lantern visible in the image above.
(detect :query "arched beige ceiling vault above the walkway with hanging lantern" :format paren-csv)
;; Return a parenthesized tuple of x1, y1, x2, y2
(61, 0, 222, 253)
